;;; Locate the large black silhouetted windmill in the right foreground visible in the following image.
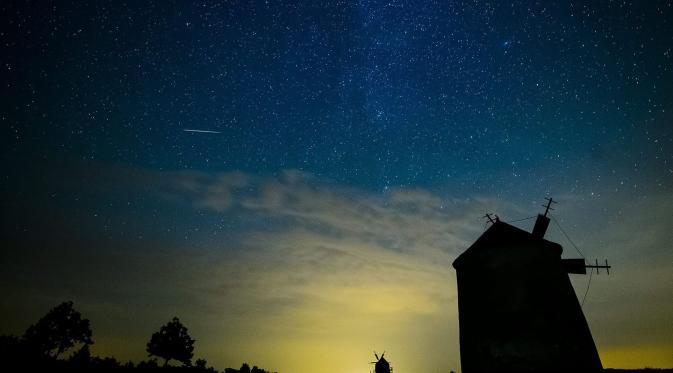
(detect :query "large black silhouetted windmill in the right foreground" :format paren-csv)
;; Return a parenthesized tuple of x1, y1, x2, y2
(453, 211, 602, 373)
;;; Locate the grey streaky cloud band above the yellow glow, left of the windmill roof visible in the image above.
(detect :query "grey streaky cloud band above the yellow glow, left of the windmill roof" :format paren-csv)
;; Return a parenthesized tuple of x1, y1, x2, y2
(185, 170, 494, 253)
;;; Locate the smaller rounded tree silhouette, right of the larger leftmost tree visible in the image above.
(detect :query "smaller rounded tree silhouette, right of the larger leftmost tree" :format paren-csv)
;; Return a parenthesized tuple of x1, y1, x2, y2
(147, 317, 194, 366)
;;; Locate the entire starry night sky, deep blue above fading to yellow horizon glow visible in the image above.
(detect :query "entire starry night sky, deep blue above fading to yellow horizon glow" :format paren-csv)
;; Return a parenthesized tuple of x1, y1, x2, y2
(0, 0, 673, 373)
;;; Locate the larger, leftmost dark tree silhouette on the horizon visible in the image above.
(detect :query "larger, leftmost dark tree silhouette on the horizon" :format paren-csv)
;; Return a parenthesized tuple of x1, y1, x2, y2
(23, 301, 93, 358)
